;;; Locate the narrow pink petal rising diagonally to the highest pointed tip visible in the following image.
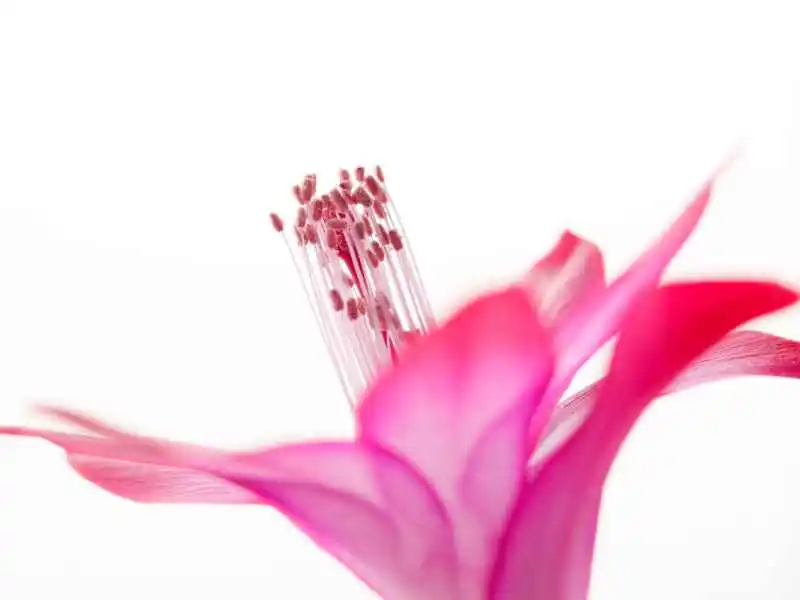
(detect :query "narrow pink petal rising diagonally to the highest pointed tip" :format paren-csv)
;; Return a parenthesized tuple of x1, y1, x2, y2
(529, 178, 715, 451)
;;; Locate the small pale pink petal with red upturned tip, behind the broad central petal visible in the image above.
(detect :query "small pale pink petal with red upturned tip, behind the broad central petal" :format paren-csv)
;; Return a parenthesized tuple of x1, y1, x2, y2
(522, 231, 606, 326)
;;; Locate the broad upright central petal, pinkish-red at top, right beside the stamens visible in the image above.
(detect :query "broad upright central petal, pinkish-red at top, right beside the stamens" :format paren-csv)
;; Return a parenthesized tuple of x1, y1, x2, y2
(358, 288, 551, 589)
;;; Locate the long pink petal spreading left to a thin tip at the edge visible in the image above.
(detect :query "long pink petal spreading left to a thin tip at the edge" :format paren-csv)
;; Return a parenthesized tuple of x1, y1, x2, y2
(0, 410, 461, 600)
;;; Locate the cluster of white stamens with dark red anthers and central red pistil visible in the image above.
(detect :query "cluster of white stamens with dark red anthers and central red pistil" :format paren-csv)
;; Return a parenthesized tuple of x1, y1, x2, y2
(270, 167, 434, 406)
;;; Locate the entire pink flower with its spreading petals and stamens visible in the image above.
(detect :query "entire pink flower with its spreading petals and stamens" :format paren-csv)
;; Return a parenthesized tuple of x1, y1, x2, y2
(0, 165, 800, 600)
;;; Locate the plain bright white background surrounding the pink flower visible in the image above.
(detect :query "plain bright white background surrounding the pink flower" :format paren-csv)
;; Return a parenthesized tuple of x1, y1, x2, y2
(0, 0, 800, 600)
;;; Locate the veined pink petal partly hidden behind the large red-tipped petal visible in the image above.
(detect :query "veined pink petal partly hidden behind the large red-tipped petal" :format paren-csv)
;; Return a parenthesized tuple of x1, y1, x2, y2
(534, 330, 800, 464)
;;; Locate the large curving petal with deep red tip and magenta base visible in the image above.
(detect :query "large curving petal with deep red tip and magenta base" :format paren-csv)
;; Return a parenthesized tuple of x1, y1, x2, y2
(489, 282, 797, 600)
